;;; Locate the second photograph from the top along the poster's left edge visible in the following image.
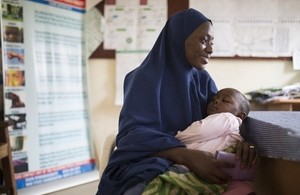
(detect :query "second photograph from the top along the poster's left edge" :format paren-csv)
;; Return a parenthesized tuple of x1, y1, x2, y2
(3, 26, 24, 43)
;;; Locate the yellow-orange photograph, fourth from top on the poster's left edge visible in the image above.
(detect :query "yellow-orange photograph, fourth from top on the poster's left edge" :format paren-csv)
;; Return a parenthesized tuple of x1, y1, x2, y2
(5, 69, 25, 87)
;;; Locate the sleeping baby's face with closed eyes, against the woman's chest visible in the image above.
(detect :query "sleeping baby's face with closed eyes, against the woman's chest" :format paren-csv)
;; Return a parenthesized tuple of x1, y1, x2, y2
(207, 88, 240, 116)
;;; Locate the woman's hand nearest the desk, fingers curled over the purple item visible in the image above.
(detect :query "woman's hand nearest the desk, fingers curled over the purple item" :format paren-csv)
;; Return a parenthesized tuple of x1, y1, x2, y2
(236, 142, 259, 168)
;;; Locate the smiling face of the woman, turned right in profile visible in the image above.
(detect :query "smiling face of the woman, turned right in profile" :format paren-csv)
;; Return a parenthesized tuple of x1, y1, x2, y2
(185, 21, 214, 70)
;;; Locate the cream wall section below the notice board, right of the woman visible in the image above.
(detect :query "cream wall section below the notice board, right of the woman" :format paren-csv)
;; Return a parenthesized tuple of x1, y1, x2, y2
(206, 59, 300, 93)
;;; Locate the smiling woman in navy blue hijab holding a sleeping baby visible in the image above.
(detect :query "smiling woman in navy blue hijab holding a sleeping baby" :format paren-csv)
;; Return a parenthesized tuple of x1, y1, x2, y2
(97, 9, 253, 195)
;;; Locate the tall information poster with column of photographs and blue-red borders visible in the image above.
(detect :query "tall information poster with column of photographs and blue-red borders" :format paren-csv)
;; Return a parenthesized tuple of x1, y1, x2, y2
(1, 0, 95, 189)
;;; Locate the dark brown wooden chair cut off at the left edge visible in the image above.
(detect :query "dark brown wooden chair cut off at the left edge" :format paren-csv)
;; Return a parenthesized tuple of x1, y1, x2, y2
(0, 122, 17, 195)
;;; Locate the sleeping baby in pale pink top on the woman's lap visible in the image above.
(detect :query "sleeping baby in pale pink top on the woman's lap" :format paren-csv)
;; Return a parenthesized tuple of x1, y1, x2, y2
(176, 88, 250, 154)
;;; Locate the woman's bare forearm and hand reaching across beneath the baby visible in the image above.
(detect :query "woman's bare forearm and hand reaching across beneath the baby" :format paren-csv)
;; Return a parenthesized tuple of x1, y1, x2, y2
(152, 147, 234, 184)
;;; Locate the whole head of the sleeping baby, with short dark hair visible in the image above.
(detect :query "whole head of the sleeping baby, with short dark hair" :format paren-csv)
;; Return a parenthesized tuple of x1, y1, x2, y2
(207, 88, 250, 120)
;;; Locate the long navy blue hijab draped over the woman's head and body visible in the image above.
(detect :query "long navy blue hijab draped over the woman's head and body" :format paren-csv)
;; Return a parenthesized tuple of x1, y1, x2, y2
(97, 9, 217, 195)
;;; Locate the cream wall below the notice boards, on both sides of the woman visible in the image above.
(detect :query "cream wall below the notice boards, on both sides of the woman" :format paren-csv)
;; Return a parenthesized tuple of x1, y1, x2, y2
(88, 59, 300, 168)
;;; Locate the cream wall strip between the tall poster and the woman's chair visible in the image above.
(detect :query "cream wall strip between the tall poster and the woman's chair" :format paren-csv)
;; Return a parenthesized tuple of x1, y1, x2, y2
(88, 59, 121, 168)
